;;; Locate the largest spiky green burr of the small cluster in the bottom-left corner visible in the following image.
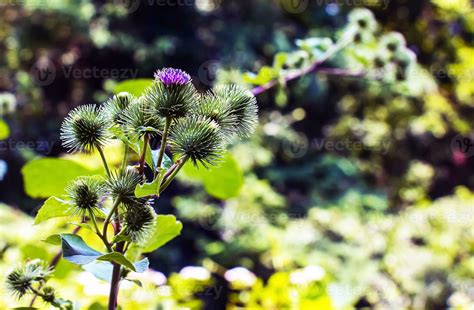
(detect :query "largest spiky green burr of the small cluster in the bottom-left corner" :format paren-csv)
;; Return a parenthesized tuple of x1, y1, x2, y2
(6, 260, 51, 299)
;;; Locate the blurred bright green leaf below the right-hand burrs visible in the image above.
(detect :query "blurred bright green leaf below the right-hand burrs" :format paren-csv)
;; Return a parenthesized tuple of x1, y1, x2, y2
(183, 153, 244, 199)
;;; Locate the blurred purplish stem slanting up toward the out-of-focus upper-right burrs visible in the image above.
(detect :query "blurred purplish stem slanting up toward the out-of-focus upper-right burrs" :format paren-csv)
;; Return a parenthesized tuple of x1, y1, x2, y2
(251, 31, 354, 96)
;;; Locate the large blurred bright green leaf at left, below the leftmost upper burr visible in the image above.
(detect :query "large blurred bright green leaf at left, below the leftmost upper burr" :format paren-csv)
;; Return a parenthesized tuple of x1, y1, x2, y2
(21, 158, 94, 198)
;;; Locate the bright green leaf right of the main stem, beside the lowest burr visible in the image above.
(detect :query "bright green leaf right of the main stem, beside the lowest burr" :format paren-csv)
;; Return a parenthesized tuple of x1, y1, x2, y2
(142, 215, 183, 253)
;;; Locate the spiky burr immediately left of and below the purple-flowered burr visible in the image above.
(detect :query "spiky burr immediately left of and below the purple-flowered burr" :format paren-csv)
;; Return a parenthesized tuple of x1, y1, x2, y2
(122, 97, 163, 138)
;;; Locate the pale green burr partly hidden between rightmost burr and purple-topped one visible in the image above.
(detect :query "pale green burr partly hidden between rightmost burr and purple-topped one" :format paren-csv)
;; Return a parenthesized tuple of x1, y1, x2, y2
(193, 91, 237, 139)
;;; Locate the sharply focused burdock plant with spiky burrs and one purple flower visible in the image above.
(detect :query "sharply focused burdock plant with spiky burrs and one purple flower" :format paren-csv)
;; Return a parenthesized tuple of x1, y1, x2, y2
(7, 68, 257, 309)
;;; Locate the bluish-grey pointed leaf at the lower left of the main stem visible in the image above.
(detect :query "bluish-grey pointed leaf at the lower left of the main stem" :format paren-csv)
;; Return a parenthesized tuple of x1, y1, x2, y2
(61, 234, 103, 265)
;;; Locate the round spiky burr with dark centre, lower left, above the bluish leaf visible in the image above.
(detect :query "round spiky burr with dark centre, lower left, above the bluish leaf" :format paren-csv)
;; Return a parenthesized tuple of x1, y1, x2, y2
(66, 176, 106, 216)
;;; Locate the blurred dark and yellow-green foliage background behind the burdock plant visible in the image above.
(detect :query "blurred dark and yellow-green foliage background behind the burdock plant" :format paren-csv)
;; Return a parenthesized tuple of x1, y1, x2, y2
(0, 0, 474, 309)
